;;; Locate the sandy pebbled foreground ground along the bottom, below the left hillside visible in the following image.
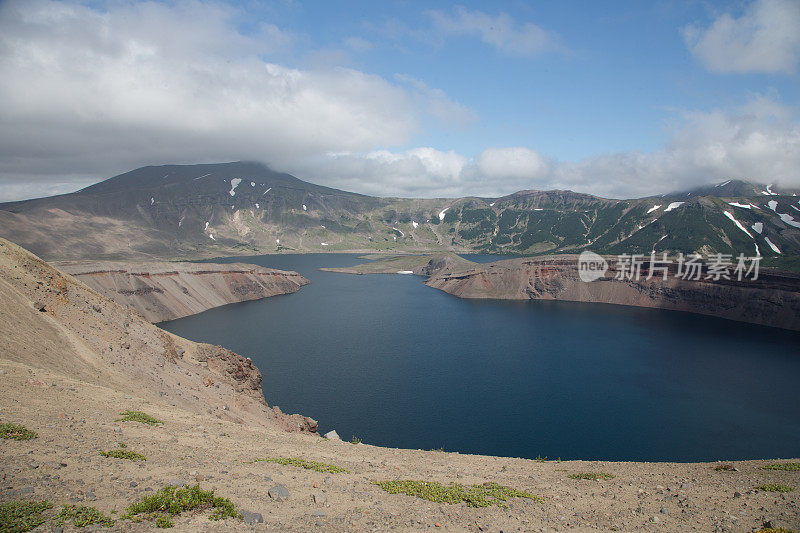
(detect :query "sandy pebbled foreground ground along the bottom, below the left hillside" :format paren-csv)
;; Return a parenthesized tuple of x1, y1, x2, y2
(0, 360, 800, 531)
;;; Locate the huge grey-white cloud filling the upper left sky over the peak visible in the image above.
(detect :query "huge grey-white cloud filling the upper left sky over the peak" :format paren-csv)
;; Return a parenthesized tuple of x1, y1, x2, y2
(0, 0, 470, 196)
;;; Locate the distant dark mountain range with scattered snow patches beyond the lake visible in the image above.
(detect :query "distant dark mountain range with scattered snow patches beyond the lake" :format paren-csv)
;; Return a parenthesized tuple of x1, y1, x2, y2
(0, 162, 800, 259)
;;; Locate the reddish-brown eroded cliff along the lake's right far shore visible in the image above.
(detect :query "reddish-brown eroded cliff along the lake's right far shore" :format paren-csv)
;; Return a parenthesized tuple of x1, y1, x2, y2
(425, 256, 800, 330)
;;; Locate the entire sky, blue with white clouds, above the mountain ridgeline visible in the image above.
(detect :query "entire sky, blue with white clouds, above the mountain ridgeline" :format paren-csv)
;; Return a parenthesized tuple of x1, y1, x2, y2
(0, 0, 800, 199)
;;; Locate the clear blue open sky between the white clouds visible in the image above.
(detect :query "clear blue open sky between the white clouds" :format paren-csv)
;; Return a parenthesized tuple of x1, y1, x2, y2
(255, 1, 800, 159)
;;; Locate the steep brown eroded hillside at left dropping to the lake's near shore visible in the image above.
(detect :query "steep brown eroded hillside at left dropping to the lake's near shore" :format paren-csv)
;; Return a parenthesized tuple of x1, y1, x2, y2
(0, 239, 317, 433)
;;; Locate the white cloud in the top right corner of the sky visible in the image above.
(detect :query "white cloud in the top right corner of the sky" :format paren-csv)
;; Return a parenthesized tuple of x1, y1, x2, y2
(684, 0, 800, 74)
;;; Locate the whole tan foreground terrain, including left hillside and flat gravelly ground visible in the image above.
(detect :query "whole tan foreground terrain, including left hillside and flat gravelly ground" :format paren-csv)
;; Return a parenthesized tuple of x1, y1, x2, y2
(0, 242, 800, 532)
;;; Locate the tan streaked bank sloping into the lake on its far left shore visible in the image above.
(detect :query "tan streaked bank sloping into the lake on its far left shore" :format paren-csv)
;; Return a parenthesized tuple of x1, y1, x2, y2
(54, 261, 309, 322)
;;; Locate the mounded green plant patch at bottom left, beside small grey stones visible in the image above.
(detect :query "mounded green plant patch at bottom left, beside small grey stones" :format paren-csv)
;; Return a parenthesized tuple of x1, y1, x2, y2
(126, 484, 241, 527)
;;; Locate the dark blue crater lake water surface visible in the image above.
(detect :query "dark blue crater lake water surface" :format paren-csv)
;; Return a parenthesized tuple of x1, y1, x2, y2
(161, 254, 800, 461)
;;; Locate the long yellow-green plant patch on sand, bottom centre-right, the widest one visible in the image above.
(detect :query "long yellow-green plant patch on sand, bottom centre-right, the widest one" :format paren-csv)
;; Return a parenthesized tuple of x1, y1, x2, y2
(374, 480, 541, 508)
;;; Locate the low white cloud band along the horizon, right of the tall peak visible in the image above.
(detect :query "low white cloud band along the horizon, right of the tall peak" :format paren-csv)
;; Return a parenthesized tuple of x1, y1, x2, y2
(290, 95, 800, 198)
